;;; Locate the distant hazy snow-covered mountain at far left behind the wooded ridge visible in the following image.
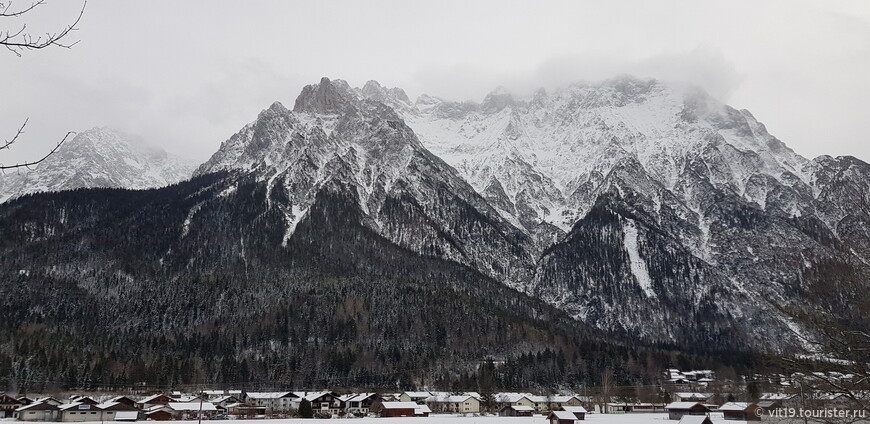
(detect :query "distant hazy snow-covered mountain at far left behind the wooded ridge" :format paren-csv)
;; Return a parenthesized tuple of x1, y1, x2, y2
(0, 128, 195, 201)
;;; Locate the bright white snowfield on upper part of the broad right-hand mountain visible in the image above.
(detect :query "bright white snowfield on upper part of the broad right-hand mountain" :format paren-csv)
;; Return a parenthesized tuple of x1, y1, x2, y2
(369, 77, 809, 235)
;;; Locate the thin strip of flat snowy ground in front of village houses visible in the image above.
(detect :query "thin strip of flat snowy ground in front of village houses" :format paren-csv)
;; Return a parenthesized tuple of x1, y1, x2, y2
(1, 413, 746, 424)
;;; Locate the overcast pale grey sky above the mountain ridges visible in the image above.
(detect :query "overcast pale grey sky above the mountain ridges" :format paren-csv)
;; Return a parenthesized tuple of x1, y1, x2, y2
(0, 0, 870, 163)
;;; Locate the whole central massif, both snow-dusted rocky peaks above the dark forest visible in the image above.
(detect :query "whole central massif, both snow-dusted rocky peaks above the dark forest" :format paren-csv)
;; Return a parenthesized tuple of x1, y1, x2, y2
(6, 77, 870, 350)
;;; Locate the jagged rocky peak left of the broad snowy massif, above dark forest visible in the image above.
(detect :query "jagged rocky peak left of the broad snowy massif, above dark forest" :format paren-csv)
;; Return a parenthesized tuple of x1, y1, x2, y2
(197, 78, 535, 285)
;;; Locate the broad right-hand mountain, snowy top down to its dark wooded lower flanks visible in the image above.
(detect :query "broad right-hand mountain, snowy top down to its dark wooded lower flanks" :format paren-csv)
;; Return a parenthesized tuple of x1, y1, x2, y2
(360, 77, 870, 350)
